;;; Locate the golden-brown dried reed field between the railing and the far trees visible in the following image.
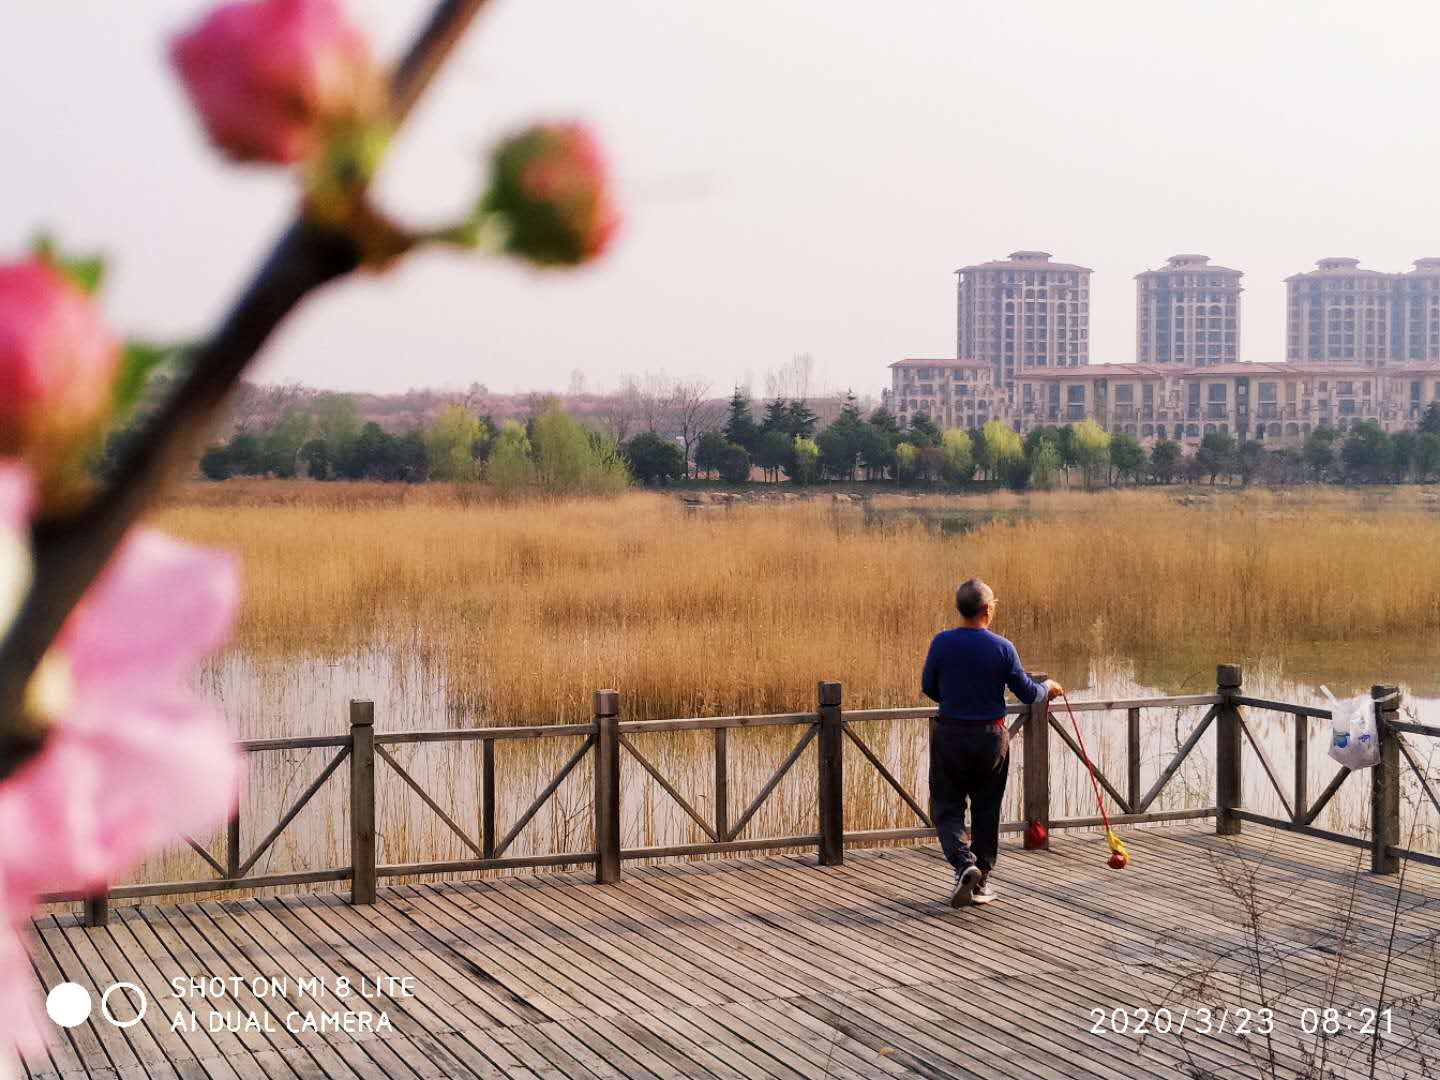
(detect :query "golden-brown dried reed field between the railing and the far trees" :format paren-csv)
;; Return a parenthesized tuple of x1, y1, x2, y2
(158, 482, 1440, 724)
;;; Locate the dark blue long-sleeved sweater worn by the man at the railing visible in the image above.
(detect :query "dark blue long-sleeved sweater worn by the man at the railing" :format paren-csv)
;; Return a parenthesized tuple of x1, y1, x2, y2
(920, 626, 1041, 723)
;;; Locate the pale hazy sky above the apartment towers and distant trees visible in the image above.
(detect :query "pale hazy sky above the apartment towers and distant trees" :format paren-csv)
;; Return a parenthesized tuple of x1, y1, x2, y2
(8, 0, 1440, 393)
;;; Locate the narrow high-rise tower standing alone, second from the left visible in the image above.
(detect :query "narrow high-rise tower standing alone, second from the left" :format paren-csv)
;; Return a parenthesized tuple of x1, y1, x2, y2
(1135, 255, 1241, 367)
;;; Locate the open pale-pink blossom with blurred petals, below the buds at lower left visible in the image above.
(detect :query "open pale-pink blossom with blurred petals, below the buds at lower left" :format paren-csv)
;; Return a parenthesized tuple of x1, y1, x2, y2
(0, 501, 239, 1053)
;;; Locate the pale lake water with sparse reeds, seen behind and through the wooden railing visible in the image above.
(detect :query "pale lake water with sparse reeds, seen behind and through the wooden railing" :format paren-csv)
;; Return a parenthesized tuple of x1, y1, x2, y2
(104, 649, 1440, 887)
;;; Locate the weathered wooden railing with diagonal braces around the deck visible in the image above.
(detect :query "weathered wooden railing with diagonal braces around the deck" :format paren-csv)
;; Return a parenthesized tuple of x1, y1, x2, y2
(42, 664, 1440, 924)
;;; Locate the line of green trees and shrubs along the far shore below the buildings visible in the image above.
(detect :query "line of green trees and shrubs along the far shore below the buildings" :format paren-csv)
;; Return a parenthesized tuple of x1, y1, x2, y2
(168, 389, 1440, 492)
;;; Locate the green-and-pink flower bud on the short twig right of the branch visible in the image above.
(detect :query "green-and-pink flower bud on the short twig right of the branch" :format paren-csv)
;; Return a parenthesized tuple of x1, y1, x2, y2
(481, 124, 619, 265)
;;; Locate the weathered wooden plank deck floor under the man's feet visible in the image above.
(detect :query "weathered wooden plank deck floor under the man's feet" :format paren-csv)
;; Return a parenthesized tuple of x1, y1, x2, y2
(19, 824, 1440, 1080)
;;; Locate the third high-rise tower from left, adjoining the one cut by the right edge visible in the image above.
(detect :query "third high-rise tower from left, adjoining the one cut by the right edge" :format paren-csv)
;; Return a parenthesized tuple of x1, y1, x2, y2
(1284, 258, 1404, 367)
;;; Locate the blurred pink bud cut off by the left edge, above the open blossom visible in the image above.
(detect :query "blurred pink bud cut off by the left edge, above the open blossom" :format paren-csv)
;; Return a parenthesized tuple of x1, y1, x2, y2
(0, 259, 121, 492)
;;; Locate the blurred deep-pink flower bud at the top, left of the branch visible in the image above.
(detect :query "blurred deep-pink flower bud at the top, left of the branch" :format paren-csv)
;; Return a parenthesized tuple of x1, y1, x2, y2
(170, 0, 384, 164)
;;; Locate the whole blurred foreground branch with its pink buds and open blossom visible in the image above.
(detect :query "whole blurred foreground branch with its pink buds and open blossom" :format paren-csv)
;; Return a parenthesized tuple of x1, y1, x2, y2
(0, 0, 619, 1074)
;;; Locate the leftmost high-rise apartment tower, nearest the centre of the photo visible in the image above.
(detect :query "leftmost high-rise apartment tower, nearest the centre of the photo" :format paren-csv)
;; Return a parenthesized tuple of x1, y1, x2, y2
(956, 251, 1090, 395)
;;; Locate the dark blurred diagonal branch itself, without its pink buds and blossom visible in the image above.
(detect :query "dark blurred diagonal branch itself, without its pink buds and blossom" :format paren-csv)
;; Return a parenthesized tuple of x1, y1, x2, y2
(0, 0, 487, 779)
